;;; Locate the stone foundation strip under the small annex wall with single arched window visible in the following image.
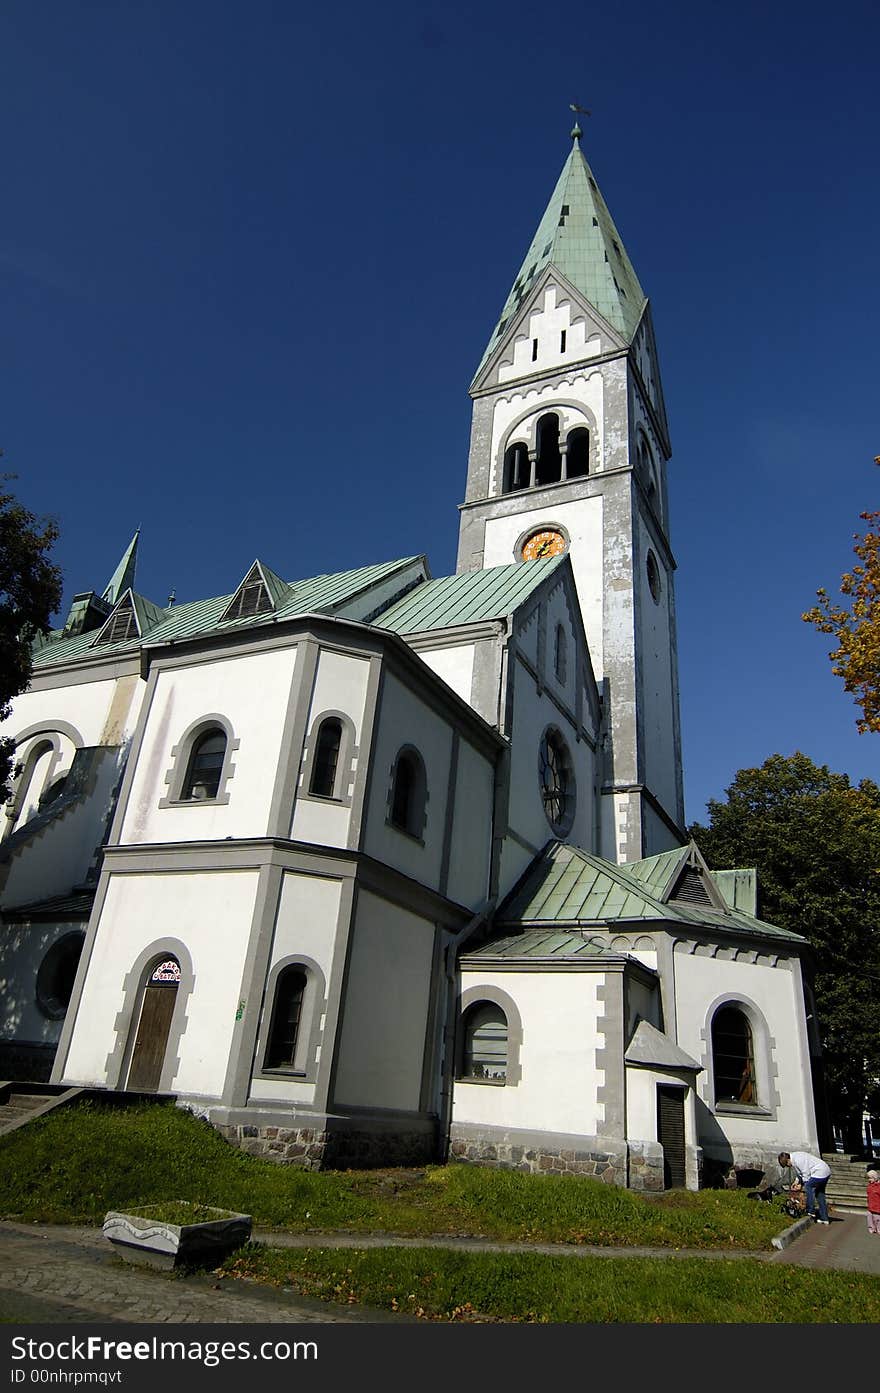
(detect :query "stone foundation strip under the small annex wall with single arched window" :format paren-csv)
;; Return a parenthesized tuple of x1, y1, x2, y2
(448, 1124, 627, 1185)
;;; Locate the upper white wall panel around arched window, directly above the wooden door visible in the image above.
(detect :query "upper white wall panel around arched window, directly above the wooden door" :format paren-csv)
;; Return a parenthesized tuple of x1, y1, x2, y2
(120, 648, 297, 843)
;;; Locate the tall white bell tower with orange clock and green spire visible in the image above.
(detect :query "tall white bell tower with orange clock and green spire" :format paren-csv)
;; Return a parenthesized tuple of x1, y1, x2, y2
(458, 125, 684, 862)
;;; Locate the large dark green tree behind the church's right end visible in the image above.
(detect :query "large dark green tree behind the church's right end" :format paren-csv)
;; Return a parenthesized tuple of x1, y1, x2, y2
(691, 754, 880, 1124)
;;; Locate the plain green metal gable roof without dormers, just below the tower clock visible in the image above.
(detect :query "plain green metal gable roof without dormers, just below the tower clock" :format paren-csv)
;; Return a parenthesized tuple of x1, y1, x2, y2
(376, 556, 564, 634)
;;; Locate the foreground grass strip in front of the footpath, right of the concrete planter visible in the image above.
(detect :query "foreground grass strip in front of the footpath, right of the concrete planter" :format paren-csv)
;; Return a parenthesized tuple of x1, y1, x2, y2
(224, 1245, 880, 1325)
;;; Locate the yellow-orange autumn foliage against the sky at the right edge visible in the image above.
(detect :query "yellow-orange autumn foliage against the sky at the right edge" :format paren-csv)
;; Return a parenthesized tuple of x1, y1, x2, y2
(802, 456, 880, 734)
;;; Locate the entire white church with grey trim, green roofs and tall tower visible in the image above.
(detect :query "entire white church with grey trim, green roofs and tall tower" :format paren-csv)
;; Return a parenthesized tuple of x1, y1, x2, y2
(0, 127, 819, 1190)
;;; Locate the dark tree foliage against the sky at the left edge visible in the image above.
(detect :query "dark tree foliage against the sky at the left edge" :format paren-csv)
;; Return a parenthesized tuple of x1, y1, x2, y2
(0, 474, 61, 801)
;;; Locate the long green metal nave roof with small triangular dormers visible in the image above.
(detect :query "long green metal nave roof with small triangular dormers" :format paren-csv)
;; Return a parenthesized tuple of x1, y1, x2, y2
(33, 556, 428, 673)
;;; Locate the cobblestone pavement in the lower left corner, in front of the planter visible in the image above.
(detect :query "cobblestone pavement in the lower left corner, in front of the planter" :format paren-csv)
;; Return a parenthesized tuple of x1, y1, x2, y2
(0, 1223, 409, 1325)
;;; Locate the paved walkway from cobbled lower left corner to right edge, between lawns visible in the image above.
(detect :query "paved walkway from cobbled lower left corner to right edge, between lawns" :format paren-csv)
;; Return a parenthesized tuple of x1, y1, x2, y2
(0, 1213, 880, 1325)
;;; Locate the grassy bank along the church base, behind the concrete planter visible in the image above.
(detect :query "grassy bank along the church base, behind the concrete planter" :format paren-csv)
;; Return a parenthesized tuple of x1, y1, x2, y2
(0, 1103, 787, 1261)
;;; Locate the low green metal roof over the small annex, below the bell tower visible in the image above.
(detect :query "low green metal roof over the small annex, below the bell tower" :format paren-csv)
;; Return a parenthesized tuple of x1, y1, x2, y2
(496, 841, 806, 943)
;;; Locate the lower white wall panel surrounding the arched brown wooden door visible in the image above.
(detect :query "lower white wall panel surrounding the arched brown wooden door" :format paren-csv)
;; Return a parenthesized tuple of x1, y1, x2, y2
(64, 871, 258, 1098)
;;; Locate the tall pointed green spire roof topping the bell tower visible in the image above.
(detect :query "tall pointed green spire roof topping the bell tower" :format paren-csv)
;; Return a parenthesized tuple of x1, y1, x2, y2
(475, 137, 645, 380)
